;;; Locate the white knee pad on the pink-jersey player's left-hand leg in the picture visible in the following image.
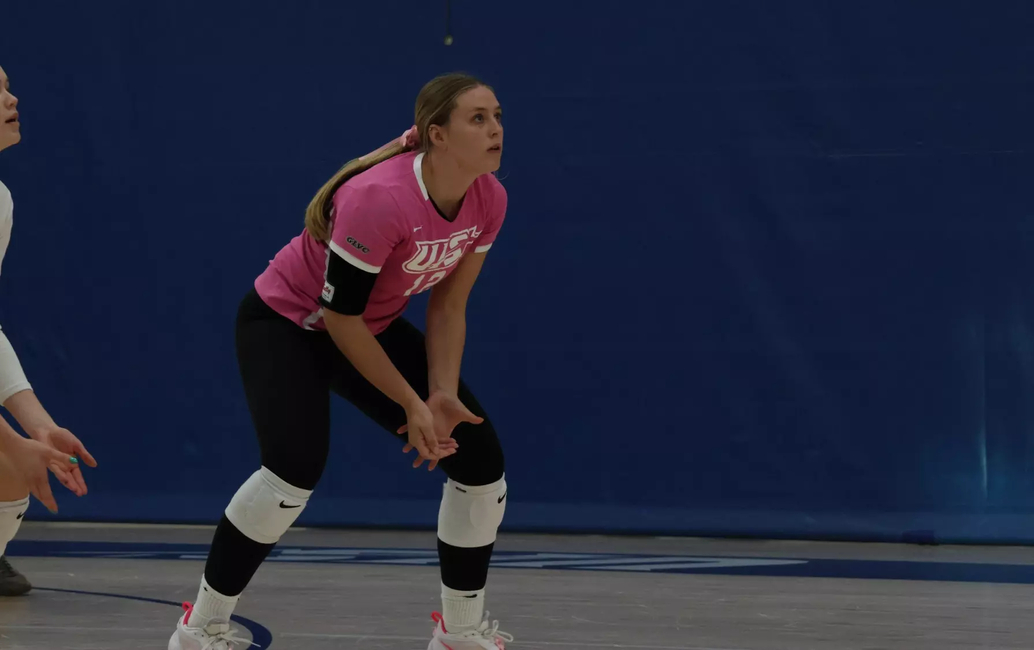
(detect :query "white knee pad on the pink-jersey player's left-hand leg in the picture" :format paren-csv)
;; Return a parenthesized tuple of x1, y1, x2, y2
(226, 467, 312, 544)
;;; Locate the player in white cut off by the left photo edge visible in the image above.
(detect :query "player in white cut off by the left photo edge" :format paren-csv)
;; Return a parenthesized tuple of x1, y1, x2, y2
(0, 67, 96, 596)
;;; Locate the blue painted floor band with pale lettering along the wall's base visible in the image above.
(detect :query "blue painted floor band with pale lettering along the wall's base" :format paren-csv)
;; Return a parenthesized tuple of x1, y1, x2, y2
(7, 540, 1034, 585)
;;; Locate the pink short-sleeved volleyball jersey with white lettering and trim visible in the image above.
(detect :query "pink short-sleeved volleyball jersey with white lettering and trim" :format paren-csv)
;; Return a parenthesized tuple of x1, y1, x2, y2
(255, 153, 507, 334)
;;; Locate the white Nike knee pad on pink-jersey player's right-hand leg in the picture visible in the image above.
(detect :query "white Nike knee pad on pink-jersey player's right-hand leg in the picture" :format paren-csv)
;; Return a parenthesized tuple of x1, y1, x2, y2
(438, 476, 507, 549)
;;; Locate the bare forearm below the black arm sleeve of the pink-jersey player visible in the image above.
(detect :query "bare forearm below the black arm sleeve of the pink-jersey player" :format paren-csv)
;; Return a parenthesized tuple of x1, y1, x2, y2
(324, 312, 421, 408)
